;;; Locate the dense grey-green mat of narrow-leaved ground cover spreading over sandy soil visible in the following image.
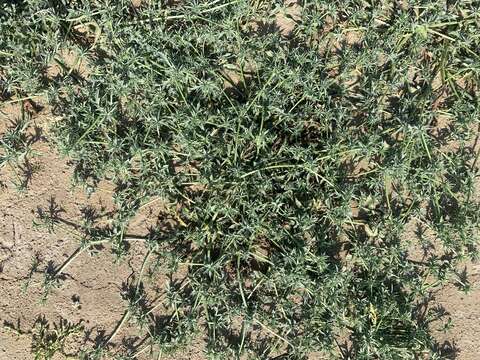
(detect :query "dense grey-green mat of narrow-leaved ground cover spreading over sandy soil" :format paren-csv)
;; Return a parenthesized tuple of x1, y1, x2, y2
(0, 0, 480, 359)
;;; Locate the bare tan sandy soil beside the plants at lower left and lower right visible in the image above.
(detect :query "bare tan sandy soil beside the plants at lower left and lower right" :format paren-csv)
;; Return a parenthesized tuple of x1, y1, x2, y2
(0, 105, 480, 360)
